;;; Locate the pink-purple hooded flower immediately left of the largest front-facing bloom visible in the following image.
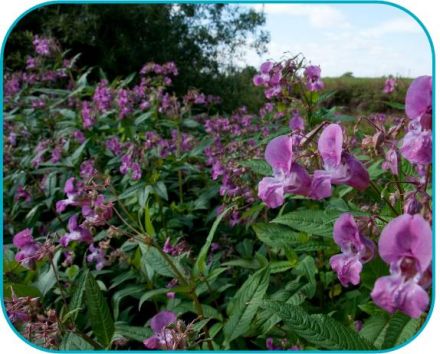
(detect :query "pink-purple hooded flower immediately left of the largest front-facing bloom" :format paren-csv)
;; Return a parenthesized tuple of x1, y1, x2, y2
(330, 213, 374, 286)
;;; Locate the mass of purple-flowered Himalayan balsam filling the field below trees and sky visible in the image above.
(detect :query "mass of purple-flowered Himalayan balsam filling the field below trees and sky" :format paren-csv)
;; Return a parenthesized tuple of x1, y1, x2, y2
(3, 36, 432, 351)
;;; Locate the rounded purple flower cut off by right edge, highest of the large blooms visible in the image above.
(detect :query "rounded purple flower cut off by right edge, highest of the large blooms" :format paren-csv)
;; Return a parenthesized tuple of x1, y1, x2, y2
(405, 75, 432, 130)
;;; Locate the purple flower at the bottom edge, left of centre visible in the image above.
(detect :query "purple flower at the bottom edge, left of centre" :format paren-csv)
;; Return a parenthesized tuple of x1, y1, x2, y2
(144, 311, 177, 350)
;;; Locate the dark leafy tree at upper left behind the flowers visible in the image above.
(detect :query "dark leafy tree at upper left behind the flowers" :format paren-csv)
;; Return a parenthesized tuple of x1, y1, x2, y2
(5, 4, 269, 108)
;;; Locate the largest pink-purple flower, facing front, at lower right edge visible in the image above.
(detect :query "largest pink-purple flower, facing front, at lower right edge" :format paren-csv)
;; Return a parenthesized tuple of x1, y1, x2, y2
(371, 214, 432, 318)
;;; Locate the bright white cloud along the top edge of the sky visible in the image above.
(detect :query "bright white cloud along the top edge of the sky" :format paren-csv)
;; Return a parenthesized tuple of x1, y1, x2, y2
(252, 4, 350, 28)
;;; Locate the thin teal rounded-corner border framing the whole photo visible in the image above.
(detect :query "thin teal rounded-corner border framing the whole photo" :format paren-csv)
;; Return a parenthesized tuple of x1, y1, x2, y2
(0, 0, 436, 353)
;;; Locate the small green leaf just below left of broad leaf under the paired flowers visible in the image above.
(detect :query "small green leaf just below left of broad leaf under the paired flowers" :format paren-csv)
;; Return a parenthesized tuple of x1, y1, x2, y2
(252, 223, 300, 248)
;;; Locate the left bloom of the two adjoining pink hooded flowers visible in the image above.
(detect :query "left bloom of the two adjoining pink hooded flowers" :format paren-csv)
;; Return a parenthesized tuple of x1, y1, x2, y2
(258, 135, 311, 208)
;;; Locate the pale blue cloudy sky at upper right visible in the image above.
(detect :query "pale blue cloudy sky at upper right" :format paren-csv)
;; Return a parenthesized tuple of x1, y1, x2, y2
(240, 4, 432, 77)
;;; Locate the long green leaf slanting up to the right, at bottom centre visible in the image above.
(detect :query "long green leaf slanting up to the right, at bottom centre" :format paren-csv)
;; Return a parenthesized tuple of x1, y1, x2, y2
(223, 267, 270, 346)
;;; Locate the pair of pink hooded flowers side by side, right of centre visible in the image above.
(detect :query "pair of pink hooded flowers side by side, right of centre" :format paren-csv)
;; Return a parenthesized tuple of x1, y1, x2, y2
(258, 124, 370, 208)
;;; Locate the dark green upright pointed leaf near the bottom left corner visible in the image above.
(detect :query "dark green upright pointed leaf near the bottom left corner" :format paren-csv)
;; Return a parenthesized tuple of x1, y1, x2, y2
(85, 273, 115, 347)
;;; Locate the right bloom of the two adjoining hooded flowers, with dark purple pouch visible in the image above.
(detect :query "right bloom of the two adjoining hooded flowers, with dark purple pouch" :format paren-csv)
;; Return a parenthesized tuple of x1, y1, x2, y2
(311, 124, 370, 199)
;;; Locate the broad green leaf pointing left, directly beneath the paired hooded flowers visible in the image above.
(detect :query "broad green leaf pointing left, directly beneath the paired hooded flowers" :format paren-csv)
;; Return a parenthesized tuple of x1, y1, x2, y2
(272, 210, 341, 237)
